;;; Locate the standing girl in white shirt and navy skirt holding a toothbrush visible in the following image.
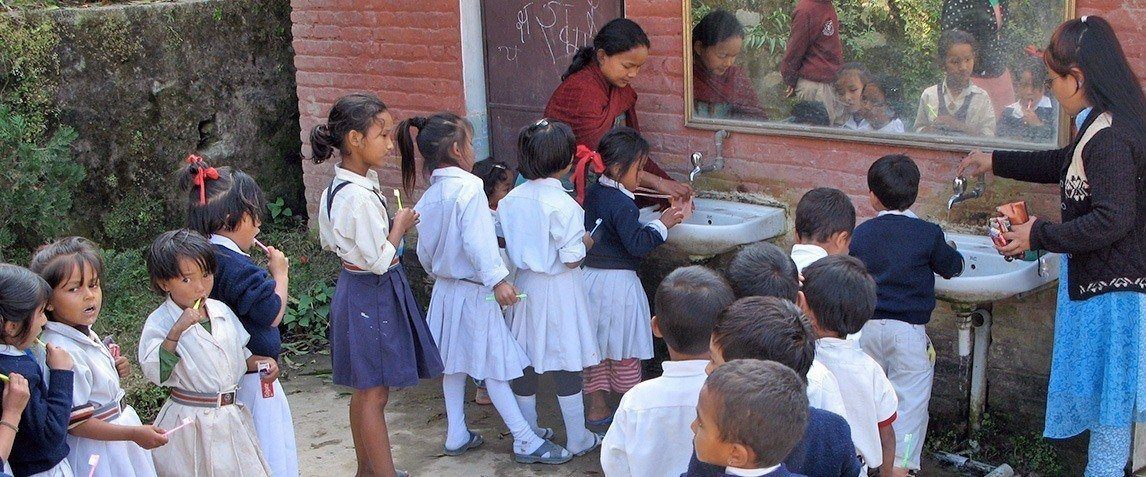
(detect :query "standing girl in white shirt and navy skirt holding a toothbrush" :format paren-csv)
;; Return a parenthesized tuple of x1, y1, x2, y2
(311, 94, 442, 476)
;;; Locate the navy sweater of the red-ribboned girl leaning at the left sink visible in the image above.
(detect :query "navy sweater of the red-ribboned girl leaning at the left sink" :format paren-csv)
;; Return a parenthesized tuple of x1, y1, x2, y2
(584, 183, 665, 269)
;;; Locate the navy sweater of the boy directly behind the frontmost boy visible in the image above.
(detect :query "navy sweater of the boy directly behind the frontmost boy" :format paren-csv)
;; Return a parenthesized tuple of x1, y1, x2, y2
(682, 407, 861, 477)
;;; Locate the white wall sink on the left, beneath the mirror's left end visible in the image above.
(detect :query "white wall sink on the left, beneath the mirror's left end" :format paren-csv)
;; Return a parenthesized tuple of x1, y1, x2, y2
(641, 198, 785, 256)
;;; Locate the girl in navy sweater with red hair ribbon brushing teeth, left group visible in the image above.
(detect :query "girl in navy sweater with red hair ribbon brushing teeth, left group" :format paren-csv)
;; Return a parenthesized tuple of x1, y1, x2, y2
(180, 155, 298, 476)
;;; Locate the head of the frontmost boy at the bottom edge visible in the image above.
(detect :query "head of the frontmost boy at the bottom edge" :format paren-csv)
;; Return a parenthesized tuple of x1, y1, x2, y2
(692, 359, 808, 477)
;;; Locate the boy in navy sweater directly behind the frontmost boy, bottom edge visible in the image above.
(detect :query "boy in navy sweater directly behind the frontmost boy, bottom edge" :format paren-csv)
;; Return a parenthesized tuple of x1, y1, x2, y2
(689, 297, 861, 477)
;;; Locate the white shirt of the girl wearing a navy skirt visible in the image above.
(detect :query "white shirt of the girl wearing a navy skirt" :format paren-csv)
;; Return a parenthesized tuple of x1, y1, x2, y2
(319, 165, 397, 275)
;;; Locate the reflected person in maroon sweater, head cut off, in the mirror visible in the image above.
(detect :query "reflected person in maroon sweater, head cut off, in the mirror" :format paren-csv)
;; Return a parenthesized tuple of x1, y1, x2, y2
(780, 0, 843, 126)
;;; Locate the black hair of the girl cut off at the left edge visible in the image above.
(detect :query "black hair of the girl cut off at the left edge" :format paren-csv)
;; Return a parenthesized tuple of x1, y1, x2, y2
(0, 264, 52, 345)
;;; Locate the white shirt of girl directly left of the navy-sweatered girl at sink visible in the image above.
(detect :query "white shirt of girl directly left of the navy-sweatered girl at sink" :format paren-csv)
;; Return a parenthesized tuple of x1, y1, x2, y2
(497, 178, 586, 275)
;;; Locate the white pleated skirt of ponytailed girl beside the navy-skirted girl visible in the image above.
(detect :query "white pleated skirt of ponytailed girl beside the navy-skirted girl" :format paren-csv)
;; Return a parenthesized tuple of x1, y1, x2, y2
(426, 279, 533, 381)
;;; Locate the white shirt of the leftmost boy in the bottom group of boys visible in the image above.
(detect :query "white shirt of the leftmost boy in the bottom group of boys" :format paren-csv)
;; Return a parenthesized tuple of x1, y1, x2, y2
(601, 360, 708, 477)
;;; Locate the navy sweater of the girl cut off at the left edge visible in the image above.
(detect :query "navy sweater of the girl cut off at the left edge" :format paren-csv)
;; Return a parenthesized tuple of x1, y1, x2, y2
(0, 354, 72, 476)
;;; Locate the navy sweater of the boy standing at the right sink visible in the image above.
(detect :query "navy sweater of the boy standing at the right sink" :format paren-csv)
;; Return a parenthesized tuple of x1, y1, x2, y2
(850, 213, 963, 324)
